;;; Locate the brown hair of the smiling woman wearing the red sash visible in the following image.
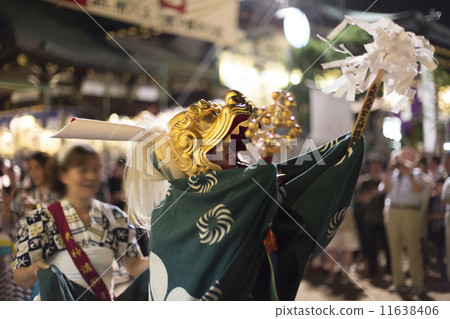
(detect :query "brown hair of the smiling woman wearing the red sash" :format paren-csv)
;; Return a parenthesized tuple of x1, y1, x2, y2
(47, 144, 101, 196)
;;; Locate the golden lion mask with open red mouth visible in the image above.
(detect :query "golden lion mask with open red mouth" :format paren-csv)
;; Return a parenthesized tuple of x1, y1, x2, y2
(154, 90, 254, 176)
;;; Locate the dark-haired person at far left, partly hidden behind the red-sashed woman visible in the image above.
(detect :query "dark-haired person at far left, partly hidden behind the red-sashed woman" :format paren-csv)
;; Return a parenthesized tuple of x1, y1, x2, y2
(3, 152, 57, 300)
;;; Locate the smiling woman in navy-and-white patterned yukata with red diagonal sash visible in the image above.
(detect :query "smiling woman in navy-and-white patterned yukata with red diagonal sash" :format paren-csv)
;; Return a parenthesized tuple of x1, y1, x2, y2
(13, 145, 148, 300)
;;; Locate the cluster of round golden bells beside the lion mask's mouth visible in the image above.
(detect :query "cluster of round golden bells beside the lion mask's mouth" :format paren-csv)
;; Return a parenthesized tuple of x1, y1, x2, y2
(245, 91, 302, 156)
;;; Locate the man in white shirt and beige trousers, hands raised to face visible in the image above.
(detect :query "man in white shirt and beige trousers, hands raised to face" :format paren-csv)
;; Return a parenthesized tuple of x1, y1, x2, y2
(380, 147, 425, 296)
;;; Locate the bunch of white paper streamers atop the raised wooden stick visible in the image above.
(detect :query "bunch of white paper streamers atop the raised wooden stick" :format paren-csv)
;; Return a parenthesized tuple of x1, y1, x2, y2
(319, 16, 437, 111)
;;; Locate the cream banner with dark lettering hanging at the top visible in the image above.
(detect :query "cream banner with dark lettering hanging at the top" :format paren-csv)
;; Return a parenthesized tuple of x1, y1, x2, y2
(43, 0, 239, 45)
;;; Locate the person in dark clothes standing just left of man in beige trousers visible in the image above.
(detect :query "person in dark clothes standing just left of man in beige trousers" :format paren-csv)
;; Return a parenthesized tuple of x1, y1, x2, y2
(360, 154, 391, 277)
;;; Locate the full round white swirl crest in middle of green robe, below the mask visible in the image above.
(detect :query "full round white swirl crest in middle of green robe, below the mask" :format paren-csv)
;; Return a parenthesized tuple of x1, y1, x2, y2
(196, 204, 234, 245)
